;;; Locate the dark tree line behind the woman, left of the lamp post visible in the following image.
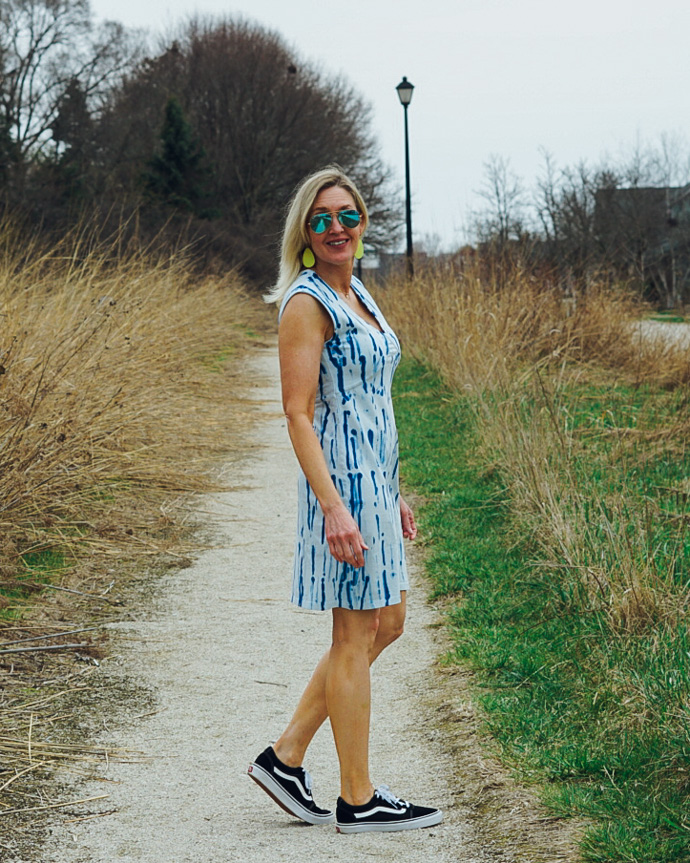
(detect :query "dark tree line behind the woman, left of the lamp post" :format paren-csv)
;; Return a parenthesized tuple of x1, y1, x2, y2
(0, 0, 400, 285)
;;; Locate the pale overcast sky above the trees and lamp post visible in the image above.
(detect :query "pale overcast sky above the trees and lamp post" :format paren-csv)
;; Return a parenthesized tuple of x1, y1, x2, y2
(92, 0, 690, 247)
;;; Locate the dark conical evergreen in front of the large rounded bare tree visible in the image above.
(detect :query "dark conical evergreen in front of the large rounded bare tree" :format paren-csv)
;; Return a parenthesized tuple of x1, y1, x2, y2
(143, 97, 209, 218)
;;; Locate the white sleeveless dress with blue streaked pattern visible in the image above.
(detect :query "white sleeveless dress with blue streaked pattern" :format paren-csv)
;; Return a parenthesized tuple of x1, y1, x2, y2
(280, 270, 409, 610)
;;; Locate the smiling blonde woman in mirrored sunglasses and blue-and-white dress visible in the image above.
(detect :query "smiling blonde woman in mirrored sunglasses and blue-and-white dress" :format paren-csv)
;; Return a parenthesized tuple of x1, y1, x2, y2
(249, 166, 442, 833)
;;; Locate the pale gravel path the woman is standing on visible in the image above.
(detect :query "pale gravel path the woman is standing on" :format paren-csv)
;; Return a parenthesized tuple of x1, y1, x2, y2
(39, 350, 478, 863)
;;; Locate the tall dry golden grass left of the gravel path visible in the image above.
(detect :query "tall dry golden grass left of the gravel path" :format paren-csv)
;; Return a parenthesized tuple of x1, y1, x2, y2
(0, 226, 267, 824)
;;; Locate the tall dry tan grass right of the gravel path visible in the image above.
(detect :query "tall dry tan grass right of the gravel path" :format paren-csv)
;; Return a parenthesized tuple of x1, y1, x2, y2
(381, 265, 690, 629)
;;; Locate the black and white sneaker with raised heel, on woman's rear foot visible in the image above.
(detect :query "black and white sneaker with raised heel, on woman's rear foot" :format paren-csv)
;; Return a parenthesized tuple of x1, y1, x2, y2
(247, 746, 335, 824)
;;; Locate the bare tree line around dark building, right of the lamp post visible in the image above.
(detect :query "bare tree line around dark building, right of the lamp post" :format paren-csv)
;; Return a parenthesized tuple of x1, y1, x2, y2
(474, 143, 690, 308)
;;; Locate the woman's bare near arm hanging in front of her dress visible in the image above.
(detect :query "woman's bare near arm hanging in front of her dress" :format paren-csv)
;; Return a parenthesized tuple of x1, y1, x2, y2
(278, 294, 367, 567)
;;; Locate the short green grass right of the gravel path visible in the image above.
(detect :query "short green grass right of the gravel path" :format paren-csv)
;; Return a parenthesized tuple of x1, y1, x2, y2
(395, 362, 690, 863)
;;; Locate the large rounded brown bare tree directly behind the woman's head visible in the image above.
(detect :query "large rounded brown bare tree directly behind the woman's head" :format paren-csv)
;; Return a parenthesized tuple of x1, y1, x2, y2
(95, 19, 402, 278)
